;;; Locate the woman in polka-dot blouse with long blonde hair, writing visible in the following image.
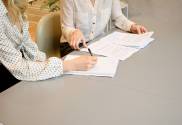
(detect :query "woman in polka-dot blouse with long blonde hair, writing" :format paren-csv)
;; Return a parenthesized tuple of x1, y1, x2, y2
(0, 0, 97, 91)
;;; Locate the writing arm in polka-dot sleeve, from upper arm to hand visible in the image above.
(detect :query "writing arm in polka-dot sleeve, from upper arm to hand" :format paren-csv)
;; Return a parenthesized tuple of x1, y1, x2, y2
(0, 34, 97, 81)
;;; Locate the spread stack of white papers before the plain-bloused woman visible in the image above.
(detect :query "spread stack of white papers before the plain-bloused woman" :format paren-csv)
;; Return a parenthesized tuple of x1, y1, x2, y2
(81, 32, 154, 60)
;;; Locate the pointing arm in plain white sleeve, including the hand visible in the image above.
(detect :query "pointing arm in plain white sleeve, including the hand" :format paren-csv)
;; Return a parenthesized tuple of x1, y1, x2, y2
(61, 0, 87, 50)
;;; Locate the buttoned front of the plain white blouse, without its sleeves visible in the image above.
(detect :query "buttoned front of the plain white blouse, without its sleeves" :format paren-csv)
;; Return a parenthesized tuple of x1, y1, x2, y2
(73, 0, 112, 40)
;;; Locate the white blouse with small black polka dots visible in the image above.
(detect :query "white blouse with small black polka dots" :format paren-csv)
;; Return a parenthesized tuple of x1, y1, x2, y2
(0, 0, 63, 81)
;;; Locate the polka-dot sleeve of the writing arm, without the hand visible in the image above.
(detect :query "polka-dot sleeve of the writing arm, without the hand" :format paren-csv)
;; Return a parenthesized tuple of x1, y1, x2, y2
(0, 28, 63, 81)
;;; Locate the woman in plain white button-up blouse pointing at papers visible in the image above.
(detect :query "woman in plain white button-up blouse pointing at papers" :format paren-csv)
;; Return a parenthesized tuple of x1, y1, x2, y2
(61, 0, 147, 49)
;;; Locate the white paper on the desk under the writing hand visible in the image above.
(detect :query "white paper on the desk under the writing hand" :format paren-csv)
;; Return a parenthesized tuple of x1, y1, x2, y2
(65, 55, 119, 77)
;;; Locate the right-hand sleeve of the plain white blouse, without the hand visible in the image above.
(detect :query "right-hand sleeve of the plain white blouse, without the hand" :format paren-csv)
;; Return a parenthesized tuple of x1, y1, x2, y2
(112, 0, 134, 31)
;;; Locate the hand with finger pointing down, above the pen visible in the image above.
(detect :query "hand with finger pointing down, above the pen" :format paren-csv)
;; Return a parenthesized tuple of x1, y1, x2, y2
(69, 29, 87, 50)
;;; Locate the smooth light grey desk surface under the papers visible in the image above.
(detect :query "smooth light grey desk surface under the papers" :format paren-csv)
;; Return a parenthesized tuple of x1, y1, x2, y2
(0, 0, 182, 125)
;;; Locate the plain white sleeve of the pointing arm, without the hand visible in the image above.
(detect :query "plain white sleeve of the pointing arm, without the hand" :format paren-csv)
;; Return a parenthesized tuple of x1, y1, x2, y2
(61, 0, 75, 42)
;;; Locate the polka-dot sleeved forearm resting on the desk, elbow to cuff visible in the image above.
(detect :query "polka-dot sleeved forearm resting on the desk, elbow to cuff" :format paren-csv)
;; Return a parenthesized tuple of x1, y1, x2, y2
(5, 57, 63, 81)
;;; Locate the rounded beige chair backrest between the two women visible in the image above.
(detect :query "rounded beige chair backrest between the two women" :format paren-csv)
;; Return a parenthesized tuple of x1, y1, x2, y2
(36, 12, 61, 57)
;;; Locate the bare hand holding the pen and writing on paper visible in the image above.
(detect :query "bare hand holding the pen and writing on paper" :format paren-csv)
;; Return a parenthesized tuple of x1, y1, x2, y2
(63, 56, 97, 72)
